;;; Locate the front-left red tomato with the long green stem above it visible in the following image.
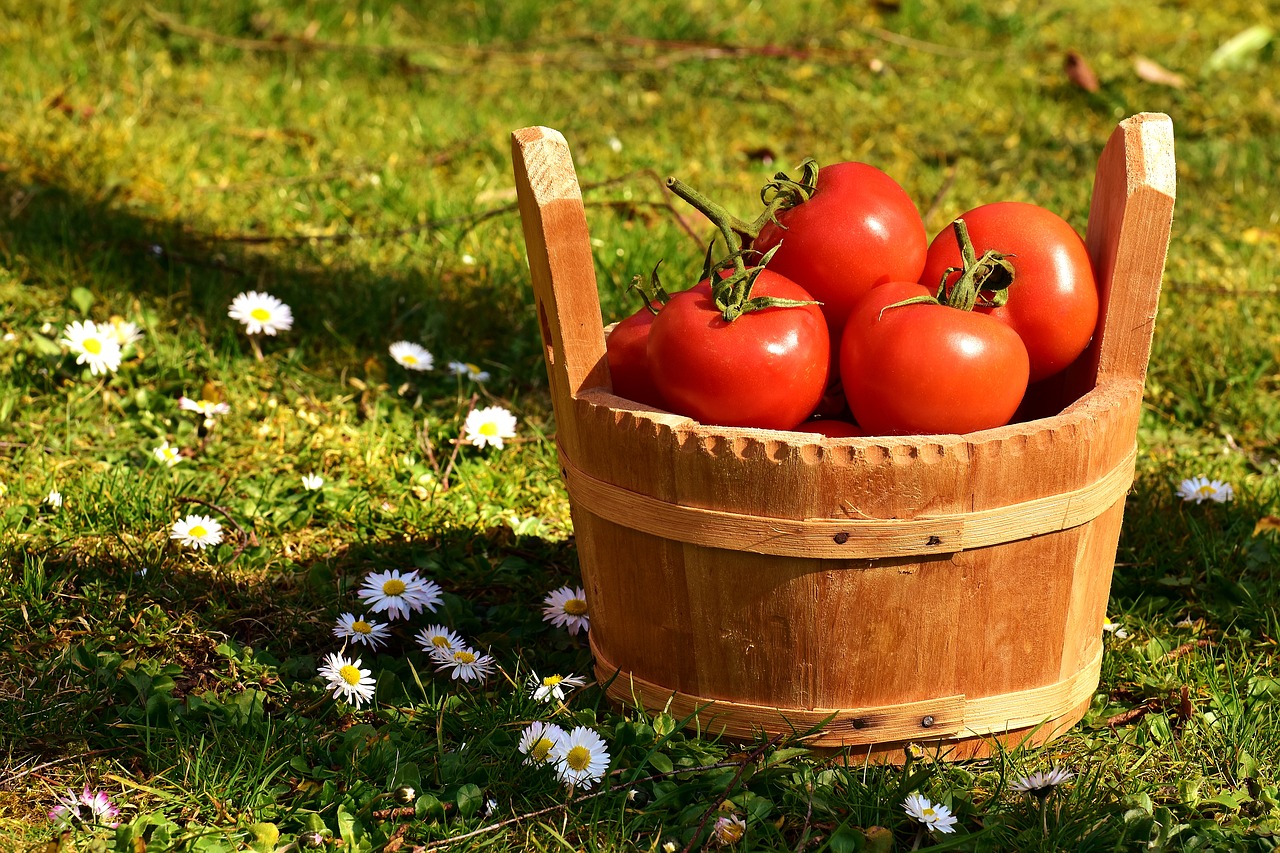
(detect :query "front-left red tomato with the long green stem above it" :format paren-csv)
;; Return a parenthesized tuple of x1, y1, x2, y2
(649, 269, 831, 429)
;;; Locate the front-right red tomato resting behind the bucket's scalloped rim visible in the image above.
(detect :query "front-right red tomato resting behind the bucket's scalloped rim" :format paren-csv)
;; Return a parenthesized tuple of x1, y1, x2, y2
(840, 282, 1028, 435)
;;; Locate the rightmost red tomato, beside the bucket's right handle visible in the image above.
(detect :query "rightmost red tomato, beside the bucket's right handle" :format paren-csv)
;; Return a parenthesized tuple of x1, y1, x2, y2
(918, 201, 1098, 382)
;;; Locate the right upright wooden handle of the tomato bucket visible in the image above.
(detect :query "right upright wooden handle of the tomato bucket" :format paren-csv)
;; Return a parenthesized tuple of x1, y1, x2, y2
(1073, 113, 1176, 384)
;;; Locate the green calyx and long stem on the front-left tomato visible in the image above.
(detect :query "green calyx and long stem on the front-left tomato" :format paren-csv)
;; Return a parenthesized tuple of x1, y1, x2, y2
(653, 172, 817, 323)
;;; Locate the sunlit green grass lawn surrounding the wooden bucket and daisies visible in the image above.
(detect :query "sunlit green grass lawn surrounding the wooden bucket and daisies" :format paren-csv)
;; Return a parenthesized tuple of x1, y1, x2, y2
(0, 0, 1280, 853)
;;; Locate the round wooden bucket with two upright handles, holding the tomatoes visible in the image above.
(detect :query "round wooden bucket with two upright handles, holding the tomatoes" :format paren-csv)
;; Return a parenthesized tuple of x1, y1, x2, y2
(512, 113, 1174, 761)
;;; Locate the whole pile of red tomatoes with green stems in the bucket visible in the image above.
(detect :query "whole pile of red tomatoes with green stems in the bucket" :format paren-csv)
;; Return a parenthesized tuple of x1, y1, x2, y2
(608, 161, 1098, 437)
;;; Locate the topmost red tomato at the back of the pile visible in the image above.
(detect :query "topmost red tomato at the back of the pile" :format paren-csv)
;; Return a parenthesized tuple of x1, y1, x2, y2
(753, 163, 929, 350)
